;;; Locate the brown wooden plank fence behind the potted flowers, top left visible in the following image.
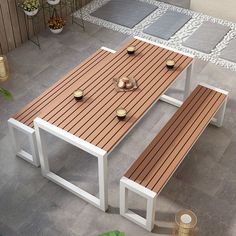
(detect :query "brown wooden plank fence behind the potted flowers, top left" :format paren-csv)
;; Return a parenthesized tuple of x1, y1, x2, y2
(0, 0, 91, 54)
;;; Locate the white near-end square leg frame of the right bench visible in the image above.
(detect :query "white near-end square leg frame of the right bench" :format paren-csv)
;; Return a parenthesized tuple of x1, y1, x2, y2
(120, 177, 157, 232)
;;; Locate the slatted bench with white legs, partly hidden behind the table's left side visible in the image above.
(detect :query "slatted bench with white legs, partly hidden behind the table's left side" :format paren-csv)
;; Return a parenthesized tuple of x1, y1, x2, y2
(8, 47, 115, 167)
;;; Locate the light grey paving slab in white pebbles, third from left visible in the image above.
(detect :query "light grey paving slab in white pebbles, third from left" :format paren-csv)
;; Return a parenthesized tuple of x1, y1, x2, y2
(183, 22, 230, 54)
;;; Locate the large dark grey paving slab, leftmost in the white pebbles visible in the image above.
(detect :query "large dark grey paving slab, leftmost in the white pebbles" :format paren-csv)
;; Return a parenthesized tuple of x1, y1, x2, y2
(91, 0, 157, 28)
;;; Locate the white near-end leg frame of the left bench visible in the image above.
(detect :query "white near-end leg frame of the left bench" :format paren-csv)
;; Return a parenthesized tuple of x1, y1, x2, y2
(8, 118, 39, 167)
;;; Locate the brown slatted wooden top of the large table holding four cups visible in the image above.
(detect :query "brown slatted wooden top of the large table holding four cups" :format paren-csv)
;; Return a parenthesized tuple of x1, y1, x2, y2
(22, 39, 192, 152)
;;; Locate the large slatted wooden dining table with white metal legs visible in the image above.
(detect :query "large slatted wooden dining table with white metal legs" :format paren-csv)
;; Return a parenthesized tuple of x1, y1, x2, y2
(34, 37, 193, 211)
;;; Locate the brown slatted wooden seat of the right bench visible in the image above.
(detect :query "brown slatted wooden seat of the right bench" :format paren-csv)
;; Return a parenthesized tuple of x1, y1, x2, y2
(125, 86, 226, 193)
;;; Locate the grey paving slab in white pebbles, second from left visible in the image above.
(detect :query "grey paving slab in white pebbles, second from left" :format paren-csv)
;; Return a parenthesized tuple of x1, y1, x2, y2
(144, 11, 192, 40)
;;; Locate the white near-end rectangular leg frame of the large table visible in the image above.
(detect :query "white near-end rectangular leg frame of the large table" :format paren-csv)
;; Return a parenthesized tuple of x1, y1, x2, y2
(34, 118, 108, 211)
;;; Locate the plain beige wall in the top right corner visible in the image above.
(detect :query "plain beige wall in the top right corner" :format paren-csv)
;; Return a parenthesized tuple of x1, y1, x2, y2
(190, 0, 236, 23)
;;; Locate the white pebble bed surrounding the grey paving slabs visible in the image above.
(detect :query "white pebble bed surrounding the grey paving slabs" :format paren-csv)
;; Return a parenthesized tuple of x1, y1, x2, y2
(75, 0, 236, 71)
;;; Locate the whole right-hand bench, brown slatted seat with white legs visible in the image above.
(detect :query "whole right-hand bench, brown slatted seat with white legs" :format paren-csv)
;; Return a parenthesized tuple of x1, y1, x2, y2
(120, 84, 228, 231)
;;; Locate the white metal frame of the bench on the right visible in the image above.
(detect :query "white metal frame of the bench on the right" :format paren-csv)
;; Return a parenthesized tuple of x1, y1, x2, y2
(120, 83, 228, 231)
